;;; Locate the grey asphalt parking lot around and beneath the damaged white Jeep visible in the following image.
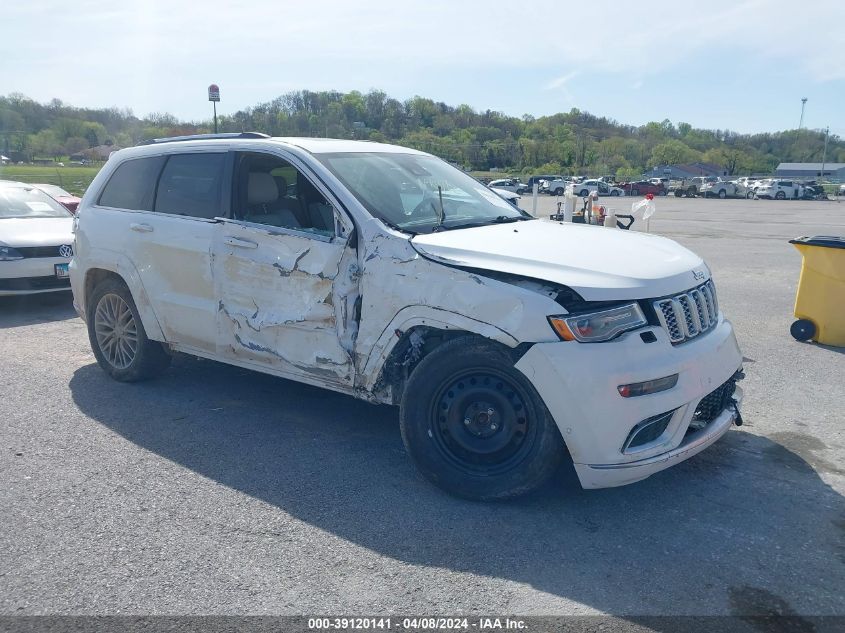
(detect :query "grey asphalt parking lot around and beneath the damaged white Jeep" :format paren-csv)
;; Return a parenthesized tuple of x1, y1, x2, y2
(0, 197, 845, 616)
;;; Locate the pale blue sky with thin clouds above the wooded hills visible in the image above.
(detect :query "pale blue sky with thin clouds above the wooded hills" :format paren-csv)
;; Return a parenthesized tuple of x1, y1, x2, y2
(0, 0, 845, 137)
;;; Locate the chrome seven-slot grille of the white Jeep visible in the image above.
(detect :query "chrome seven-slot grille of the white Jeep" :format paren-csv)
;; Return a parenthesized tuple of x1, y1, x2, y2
(654, 280, 719, 345)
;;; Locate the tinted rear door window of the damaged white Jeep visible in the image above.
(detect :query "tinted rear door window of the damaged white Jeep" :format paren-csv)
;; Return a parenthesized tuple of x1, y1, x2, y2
(154, 153, 226, 219)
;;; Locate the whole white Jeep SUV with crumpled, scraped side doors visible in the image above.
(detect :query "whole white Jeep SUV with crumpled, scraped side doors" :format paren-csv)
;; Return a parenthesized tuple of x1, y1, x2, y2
(70, 133, 742, 499)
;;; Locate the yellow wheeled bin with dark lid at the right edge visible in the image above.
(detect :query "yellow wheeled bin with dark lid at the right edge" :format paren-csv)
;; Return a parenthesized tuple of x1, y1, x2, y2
(789, 235, 845, 347)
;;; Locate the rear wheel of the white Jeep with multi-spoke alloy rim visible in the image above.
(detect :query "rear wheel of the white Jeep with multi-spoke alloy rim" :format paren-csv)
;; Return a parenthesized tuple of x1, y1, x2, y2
(87, 279, 170, 382)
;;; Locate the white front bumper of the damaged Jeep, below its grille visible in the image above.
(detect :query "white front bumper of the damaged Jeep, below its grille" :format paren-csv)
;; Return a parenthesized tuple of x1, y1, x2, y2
(516, 318, 742, 488)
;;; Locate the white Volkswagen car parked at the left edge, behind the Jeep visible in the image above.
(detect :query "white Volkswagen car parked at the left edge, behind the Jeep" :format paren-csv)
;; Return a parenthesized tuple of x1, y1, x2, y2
(0, 181, 73, 295)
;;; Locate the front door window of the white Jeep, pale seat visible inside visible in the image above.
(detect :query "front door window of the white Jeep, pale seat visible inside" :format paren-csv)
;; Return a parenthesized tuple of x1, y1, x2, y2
(233, 152, 335, 237)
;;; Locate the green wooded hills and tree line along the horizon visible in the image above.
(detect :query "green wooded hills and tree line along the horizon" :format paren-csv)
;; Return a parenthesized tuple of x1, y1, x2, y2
(0, 90, 845, 180)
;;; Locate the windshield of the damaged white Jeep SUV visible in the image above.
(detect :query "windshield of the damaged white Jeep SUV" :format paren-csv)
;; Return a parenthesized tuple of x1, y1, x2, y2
(316, 152, 531, 233)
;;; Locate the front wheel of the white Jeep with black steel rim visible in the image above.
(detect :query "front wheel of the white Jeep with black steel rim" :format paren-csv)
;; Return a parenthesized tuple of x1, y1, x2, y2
(399, 336, 566, 500)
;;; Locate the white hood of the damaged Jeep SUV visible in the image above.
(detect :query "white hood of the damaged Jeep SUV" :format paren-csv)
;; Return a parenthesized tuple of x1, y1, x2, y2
(411, 220, 710, 301)
